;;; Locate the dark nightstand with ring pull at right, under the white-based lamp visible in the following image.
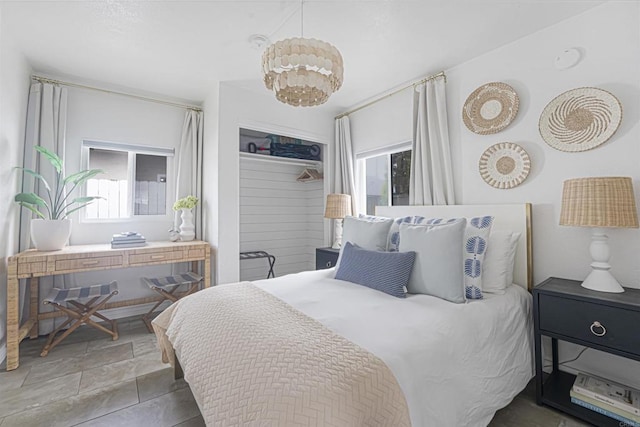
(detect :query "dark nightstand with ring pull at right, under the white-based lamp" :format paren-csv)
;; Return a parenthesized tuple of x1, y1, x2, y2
(533, 277, 640, 427)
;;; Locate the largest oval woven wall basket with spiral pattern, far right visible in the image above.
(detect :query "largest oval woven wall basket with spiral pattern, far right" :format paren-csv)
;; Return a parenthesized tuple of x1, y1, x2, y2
(538, 87, 622, 152)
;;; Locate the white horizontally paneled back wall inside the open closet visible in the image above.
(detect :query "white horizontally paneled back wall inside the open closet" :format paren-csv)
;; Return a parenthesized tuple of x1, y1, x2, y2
(240, 157, 324, 280)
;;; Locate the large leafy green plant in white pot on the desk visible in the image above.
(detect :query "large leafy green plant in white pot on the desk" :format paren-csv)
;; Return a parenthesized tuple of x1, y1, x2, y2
(14, 145, 103, 251)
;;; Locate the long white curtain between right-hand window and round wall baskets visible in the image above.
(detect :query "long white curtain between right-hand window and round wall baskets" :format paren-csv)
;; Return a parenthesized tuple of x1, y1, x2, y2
(409, 77, 455, 205)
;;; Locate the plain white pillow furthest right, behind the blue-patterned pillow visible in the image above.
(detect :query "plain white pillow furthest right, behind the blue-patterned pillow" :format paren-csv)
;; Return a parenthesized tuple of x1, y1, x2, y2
(482, 231, 520, 294)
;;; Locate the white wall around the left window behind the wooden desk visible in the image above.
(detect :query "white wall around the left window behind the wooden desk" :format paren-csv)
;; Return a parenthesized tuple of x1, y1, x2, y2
(49, 87, 185, 318)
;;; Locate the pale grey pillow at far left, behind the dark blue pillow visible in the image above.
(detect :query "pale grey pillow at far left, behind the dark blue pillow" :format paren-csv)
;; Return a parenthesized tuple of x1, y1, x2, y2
(336, 216, 393, 270)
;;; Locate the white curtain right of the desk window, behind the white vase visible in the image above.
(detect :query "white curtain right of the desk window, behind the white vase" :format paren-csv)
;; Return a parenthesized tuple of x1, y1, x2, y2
(175, 110, 204, 239)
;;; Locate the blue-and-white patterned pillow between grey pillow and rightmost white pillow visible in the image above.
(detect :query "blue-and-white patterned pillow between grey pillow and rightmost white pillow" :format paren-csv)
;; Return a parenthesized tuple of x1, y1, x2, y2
(463, 216, 493, 299)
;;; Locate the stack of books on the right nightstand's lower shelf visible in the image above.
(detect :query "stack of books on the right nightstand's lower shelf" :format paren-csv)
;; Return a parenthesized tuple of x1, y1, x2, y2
(569, 374, 640, 427)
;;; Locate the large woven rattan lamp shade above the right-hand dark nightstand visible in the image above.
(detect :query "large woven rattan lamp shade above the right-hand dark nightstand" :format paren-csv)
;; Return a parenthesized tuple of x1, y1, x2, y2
(560, 177, 638, 228)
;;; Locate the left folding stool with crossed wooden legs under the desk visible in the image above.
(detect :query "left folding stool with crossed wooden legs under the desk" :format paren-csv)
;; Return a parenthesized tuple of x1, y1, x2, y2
(40, 281, 118, 357)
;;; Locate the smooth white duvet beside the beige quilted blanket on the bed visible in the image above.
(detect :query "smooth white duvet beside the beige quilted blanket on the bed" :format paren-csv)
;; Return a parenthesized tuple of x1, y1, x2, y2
(254, 269, 533, 427)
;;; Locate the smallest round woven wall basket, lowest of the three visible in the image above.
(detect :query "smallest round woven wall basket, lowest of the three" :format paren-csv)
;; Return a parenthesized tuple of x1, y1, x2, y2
(478, 142, 531, 189)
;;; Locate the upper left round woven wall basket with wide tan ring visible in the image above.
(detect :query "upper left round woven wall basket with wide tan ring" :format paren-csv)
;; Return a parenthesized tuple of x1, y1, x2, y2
(462, 82, 520, 135)
